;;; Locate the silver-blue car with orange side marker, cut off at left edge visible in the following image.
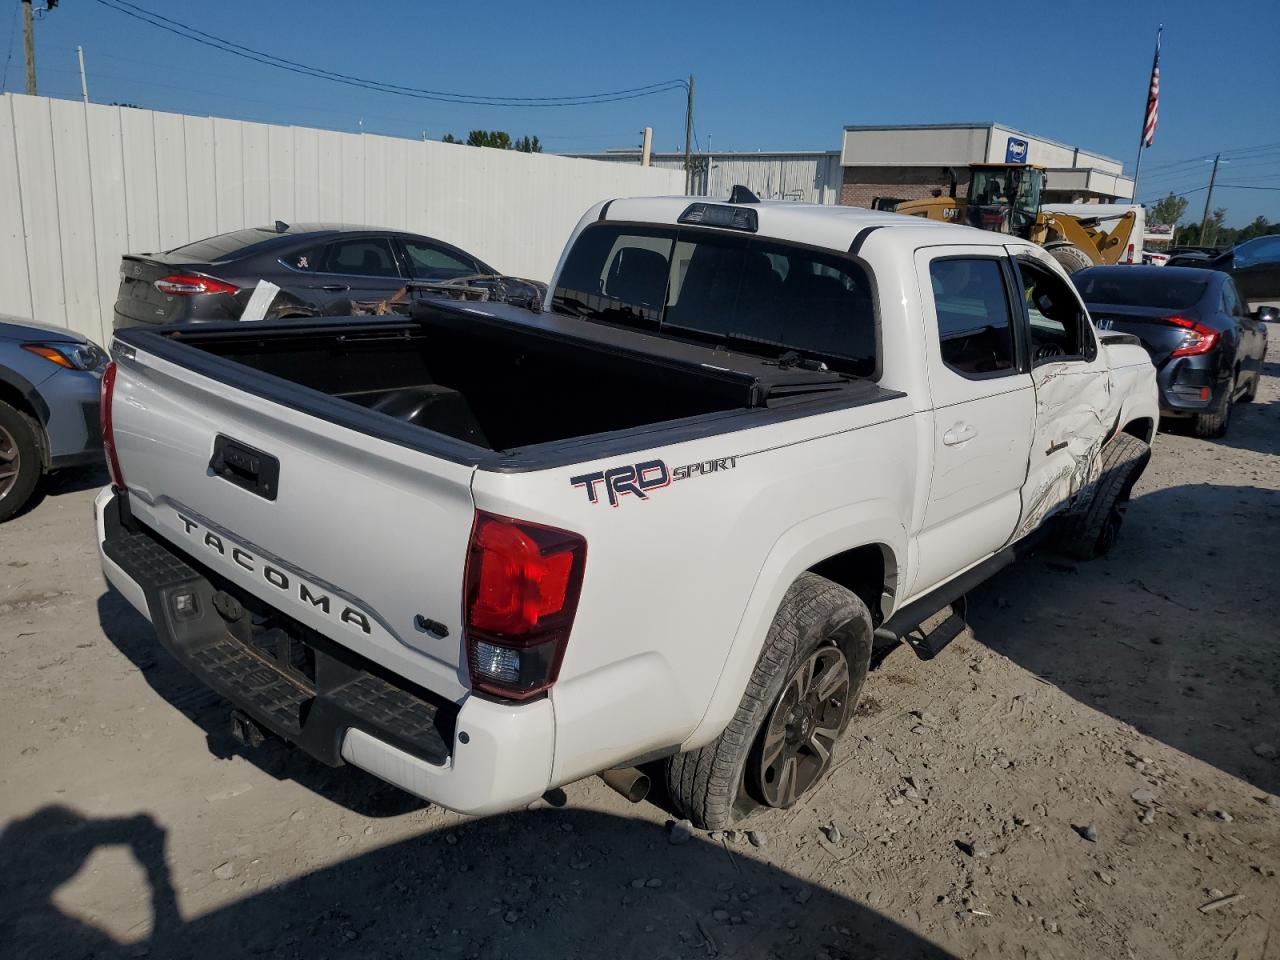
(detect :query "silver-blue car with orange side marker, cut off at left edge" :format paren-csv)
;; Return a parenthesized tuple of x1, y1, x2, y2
(0, 315, 108, 522)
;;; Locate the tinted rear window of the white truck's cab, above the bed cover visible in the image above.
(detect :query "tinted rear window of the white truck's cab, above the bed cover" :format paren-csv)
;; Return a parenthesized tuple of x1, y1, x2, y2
(553, 224, 877, 376)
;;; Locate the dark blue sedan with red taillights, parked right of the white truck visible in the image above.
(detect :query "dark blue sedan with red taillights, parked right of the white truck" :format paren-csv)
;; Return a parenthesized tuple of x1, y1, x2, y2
(1071, 266, 1277, 436)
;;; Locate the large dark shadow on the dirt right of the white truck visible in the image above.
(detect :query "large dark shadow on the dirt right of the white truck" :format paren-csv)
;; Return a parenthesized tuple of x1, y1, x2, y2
(969, 403, 1280, 794)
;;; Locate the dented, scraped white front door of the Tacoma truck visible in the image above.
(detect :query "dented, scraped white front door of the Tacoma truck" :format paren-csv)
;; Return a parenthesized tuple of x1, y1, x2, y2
(1009, 246, 1117, 536)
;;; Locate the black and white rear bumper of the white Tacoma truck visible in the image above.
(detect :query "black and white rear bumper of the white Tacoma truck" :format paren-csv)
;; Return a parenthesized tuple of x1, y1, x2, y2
(95, 488, 554, 814)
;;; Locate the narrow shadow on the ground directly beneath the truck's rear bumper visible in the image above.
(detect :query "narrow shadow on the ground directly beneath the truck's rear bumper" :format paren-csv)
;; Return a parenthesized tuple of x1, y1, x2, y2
(97, 589, 426, 817)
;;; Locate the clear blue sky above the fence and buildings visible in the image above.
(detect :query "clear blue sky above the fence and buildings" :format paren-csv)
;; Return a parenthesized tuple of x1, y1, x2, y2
(0, 0, 1280, 225)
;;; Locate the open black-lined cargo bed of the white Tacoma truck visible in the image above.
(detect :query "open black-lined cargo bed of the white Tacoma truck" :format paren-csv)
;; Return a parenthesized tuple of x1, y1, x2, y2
(118, 296, 890, 470)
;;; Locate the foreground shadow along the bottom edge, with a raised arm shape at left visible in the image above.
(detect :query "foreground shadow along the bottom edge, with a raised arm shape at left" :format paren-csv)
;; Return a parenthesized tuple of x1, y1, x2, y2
(0, 806, 951, 960)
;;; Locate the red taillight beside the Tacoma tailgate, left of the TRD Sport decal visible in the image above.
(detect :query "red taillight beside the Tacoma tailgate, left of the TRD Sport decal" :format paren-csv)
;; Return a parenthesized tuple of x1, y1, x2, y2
(463, 511, 586, 700)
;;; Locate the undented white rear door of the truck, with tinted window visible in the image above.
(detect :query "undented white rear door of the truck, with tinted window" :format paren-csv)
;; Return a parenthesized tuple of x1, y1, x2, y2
(908, 246, 1036, 595)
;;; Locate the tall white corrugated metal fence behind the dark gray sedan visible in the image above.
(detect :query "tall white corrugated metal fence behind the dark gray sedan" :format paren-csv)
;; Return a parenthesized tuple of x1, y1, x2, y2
(0, 93, 684, 343)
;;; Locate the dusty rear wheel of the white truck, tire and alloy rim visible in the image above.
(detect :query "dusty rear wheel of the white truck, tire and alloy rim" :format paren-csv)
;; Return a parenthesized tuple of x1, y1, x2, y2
(667, 573, 872, 829)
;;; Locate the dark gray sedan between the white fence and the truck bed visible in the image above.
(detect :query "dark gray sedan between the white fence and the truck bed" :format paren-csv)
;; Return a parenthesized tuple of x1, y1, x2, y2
(114, 223, 494, 329)
